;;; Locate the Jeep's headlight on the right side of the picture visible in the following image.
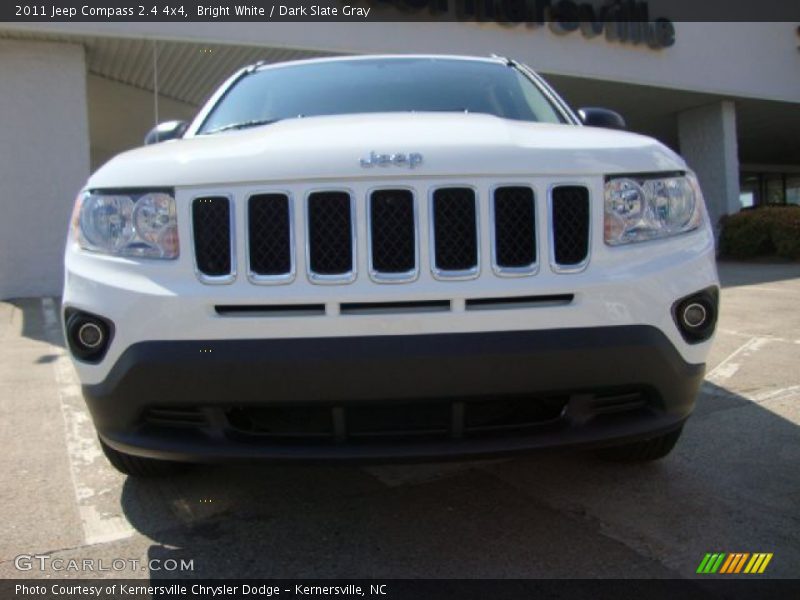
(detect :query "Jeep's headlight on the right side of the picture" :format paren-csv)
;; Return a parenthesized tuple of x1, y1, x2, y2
(605, 174, 703, 246)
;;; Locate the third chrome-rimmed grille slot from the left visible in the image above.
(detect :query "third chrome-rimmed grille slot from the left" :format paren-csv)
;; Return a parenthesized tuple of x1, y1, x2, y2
(308, 192, 354, 277)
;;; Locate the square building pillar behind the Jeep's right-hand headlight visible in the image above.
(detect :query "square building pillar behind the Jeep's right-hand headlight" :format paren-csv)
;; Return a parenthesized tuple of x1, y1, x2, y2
(678, 100, 740, 229)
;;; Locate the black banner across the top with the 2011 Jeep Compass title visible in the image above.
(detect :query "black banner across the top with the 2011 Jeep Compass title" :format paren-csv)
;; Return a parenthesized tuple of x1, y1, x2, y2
(0, 0, 800, 22)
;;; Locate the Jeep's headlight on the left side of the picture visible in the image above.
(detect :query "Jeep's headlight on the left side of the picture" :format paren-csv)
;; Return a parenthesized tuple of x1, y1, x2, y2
(73, 191, 178, 258)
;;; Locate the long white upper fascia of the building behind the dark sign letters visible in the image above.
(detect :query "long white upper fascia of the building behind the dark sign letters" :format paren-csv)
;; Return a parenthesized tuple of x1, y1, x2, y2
(2, 20, 800, 102)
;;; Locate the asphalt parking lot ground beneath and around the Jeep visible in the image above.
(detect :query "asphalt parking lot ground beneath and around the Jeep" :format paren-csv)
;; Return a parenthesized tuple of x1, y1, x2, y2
(0, 263, 800, 579)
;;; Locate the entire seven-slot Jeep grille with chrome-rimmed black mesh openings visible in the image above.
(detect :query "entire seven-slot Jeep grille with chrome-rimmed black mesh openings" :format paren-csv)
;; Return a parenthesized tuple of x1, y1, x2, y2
(189, 182, 591, 284)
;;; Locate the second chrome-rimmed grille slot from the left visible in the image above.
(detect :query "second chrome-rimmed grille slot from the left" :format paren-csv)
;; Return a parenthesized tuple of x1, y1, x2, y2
(247, 194, 292, 279)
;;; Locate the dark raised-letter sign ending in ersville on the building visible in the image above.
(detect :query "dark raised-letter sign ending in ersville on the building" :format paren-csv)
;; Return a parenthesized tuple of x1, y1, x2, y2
(365, 0, 675, 50)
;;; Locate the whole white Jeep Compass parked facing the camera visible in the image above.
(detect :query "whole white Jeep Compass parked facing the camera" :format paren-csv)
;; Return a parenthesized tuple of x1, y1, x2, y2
(63, 56, 718, 475)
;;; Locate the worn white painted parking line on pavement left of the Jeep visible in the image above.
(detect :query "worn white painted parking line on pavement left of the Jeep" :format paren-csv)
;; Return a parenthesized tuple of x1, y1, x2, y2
(42, 298, 134, 545)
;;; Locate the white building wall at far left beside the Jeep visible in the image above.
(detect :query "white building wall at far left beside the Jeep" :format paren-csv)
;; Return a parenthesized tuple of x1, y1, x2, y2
(0, 40, 89, 298)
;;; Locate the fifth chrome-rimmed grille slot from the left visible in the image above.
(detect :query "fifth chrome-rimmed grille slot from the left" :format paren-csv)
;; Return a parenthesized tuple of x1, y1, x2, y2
(431, 188, 478, 275)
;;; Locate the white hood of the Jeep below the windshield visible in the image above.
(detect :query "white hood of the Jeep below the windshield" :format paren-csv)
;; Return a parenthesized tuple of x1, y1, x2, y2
(87, 113, 685, 188)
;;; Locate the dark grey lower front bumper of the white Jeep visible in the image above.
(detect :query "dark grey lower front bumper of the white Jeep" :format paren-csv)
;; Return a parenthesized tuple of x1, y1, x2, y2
(83, 325, 704, 462)
